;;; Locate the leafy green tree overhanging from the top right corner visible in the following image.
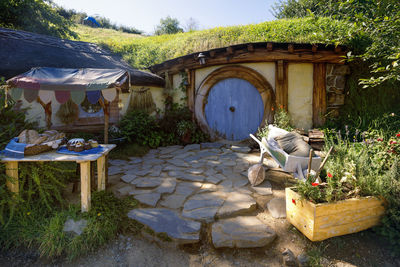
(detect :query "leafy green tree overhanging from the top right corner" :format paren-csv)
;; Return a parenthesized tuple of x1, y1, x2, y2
(272, 0, 400, 87)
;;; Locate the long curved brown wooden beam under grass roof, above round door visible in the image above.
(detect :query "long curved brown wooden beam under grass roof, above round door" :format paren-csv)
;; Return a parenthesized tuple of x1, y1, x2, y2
(152, 48, 346, 75)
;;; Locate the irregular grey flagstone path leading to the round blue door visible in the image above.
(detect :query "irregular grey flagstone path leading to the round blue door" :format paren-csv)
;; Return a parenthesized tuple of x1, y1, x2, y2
(109, 143, 282, 247)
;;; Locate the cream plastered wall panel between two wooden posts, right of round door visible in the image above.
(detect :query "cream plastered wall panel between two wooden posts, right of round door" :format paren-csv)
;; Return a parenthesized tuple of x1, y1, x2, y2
(288, 63, 313, 130)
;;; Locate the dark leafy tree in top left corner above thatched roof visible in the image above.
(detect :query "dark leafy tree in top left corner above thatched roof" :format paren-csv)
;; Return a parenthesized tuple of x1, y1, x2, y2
(0, 0, 76, 38)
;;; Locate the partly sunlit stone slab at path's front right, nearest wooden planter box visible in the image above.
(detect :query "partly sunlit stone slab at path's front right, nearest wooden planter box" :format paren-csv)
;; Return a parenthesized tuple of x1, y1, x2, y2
(211, 216, 276, 248)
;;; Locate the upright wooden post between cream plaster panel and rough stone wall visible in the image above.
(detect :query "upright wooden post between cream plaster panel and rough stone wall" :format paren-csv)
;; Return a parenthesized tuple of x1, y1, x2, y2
(313, 63, 327, 127)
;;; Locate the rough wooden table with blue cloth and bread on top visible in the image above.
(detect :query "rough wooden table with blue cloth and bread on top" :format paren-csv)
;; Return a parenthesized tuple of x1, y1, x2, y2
(0, 144, 116, 212)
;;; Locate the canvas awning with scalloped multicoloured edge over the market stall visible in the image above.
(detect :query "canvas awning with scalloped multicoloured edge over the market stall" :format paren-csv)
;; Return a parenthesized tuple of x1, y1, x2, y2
(7, 67, 129, 105)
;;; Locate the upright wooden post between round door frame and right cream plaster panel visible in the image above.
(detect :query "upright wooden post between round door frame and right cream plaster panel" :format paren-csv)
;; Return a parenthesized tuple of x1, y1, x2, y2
(275, 60, 288, 111)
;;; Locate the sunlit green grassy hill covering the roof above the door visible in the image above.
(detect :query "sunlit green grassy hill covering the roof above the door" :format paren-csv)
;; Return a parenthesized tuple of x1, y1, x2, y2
(75, 18, 353, 69)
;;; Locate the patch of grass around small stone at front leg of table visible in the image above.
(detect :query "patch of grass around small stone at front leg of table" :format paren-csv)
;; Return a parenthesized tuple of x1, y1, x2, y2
(39, 191, 137, 259)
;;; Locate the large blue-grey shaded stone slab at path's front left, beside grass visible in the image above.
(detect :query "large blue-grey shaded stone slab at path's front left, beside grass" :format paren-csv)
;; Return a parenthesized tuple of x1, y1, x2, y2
(128, 208, 201, 244)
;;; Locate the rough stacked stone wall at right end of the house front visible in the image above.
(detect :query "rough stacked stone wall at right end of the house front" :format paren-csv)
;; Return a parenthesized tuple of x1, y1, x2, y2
(326, 64, 350, 117)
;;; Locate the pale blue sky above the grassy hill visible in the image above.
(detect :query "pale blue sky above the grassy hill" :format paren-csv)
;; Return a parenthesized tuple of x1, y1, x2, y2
(53, 0, 276, 34)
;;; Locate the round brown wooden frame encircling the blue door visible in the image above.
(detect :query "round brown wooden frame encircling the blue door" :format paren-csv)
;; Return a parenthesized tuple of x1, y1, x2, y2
(195, 65, 275, 140)
